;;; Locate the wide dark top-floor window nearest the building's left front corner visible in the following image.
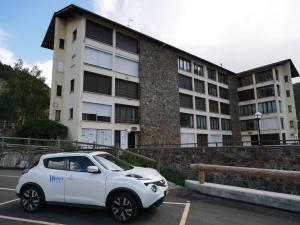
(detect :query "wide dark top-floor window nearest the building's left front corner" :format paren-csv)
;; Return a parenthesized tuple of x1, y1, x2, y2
(85, 20, 113, 45)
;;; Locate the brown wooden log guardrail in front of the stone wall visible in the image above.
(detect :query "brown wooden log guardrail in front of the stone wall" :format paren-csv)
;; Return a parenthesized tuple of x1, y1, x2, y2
(190, 163, 300, 184)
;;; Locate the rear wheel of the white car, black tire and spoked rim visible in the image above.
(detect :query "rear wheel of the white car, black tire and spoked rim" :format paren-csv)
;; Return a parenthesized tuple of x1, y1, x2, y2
(21, 186, 45, 212)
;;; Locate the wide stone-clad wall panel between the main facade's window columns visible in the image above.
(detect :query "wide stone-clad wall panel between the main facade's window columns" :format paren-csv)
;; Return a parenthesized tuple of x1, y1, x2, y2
(139, 38, 180, 145)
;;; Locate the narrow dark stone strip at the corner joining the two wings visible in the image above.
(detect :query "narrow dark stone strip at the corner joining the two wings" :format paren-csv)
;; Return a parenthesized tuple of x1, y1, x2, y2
(228, 75, 242, 145)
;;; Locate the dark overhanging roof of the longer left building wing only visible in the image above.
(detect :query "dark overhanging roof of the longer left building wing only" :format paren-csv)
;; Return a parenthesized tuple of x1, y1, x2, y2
(41, 4, 236, 75)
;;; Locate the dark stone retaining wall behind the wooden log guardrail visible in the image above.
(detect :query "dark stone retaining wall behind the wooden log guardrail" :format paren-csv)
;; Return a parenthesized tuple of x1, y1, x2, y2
(132, 146, 300, 195)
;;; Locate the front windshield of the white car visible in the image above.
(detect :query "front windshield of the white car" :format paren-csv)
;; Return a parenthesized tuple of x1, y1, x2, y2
(94, 154, 133, 171)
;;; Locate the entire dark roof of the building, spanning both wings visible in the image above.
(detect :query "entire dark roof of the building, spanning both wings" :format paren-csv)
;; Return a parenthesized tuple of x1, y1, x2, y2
(41, 4, 299, 77)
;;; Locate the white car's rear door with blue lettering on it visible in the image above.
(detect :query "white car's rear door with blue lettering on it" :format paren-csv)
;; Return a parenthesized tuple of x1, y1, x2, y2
(39, 157, 66, 202)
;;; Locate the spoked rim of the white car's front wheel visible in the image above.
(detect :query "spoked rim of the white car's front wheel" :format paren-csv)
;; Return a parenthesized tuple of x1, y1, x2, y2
(112, 197, 133, 221)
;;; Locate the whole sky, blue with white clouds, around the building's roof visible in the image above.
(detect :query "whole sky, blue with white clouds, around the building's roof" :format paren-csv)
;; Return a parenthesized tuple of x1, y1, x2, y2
(0, 0, 300, 86)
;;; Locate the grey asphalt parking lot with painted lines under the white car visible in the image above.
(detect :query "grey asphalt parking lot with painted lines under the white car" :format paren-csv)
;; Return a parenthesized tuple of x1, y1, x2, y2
(0, 169, 300, 225)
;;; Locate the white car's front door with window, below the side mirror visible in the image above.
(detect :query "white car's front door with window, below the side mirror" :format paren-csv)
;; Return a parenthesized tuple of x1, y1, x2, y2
(65, 156, 106, 206)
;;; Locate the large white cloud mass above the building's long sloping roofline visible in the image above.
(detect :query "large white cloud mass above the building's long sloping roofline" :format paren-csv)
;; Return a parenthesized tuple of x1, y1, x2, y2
(93, 0, 300, 82)
